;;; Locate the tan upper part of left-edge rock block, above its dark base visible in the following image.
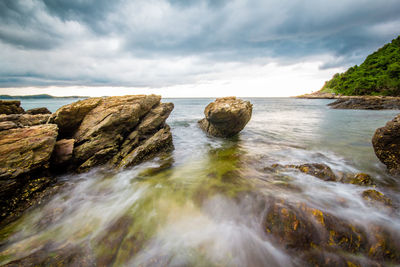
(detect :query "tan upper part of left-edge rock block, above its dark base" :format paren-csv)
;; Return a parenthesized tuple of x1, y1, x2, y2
(0, 124, 58, 179)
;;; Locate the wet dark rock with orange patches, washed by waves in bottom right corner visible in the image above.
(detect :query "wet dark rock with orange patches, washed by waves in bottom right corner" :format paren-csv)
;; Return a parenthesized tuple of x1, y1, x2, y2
(263, 198, 400, 266)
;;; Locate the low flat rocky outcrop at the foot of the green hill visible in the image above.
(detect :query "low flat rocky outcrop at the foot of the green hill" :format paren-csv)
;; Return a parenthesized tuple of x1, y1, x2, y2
(328, 96, 400, 110)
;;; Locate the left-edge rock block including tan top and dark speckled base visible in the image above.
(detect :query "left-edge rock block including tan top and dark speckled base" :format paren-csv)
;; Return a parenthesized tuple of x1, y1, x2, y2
(0, 124, 58, 220)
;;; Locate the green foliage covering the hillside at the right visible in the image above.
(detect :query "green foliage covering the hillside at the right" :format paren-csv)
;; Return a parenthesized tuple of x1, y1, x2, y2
(321, 36, 400, 96)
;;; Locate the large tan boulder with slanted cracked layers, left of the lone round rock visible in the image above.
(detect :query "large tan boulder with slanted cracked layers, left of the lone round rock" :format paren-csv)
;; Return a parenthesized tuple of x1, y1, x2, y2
(49, 95, 174, 172)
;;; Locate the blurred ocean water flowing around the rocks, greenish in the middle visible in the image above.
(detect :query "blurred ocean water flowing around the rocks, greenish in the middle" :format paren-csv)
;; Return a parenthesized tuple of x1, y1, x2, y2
(0, 98, 400, 266)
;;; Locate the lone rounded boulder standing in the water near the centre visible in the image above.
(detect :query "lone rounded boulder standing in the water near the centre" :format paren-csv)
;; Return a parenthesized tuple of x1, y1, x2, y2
(199, 97, 253, 137)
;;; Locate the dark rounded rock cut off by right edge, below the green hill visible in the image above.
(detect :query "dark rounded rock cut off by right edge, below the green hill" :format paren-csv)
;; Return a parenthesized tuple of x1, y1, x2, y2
(372, 115, 400, 175)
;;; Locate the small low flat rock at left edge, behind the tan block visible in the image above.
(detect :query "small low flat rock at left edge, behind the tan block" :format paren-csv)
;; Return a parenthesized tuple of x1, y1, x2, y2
(0, 114, 50, 131)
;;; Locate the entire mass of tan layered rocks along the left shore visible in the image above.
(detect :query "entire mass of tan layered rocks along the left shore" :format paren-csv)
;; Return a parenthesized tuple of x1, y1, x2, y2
(0, 95, 174, 225)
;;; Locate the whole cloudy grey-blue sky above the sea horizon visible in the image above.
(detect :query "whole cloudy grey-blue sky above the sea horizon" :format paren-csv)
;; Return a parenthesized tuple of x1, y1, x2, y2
(0, 0, 400, 97)
